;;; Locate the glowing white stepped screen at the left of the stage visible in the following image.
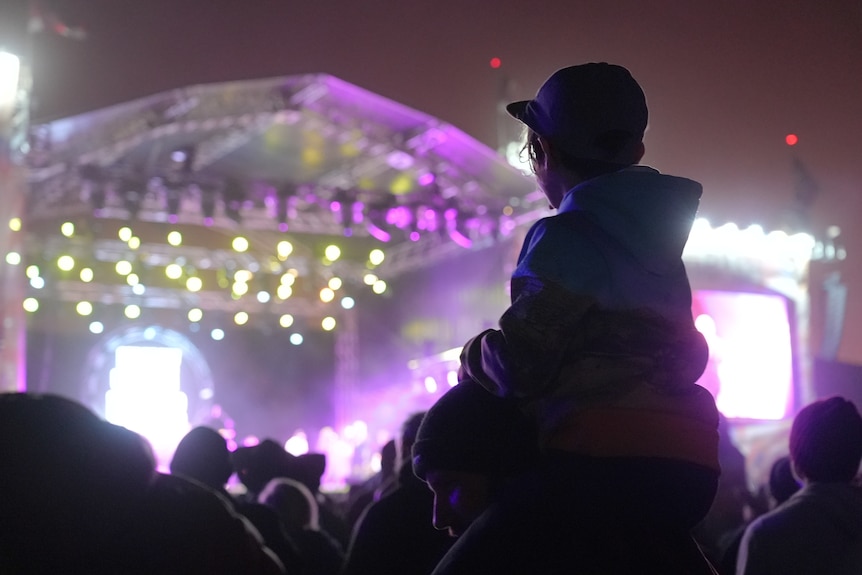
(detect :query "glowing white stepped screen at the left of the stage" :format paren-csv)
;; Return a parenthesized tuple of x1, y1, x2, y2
(105, 346, 190, 472)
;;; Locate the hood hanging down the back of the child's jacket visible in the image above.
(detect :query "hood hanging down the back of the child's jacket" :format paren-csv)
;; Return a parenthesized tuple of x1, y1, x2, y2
(560, 166, 703, 274)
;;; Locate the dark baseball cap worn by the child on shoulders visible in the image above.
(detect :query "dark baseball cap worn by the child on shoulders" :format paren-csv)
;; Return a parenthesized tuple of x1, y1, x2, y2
(506, 62, 648, 160)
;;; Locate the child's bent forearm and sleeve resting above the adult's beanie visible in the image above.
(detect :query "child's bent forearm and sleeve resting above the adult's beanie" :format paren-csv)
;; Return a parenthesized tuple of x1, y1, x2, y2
(461, 278, 595, 398)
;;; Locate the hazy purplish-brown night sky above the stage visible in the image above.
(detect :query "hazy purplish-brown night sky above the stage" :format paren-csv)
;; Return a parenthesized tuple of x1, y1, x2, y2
(15, 0, 862, 363)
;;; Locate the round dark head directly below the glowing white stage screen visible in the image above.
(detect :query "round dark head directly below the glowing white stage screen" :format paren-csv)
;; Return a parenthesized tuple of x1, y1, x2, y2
(171, 427, 233, 489)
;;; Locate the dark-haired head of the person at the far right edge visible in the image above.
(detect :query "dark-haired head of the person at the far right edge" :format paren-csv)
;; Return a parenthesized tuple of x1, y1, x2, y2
(790, 397, 862, 483)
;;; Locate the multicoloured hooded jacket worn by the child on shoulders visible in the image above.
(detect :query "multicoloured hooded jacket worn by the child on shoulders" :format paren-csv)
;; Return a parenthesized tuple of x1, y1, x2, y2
(461, 166, 718, 469)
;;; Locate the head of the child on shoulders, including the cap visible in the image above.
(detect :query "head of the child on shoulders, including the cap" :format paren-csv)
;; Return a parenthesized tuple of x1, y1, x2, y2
(506, 62, 648, 208)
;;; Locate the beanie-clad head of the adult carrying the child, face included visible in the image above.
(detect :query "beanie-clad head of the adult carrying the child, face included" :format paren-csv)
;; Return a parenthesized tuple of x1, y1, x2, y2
(413, 380, 538, 537)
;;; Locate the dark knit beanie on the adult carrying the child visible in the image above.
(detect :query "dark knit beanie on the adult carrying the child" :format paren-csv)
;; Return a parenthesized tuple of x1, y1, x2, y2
(413, 380, 538, 480)
